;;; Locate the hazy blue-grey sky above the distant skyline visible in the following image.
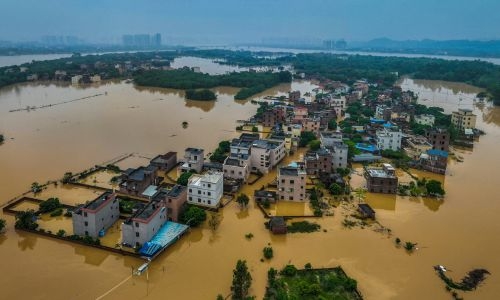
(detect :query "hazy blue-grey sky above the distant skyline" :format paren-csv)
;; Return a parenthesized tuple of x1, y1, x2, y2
(0, 0, 500, 43)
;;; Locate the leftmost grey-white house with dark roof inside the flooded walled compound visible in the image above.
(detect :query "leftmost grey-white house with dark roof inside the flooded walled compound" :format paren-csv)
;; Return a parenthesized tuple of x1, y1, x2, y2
(72, 191, 120, 238)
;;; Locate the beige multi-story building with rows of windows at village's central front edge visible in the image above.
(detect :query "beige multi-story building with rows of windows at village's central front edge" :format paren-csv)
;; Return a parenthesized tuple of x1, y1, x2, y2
(278, 166, 307, 201)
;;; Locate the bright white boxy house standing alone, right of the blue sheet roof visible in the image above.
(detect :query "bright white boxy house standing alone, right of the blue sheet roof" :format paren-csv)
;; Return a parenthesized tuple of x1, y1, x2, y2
(187, 172, 224, 208)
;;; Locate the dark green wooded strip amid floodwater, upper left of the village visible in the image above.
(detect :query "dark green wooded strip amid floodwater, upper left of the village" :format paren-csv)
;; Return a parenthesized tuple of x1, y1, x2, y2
(134, 68, 292, 100)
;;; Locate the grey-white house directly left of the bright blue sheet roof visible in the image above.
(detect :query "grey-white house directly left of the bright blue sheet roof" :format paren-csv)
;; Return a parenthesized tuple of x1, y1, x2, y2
(122, 201, 167, 247)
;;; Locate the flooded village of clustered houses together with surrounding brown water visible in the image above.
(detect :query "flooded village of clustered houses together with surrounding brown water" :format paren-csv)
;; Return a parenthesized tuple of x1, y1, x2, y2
(0, 57, 500, 299)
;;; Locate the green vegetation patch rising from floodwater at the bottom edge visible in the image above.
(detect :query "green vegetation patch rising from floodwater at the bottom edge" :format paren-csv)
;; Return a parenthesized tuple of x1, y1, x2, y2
(264, 265, 361, 300)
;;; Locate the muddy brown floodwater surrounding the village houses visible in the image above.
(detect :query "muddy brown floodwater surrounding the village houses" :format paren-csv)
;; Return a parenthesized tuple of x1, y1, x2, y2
(0, 75, 500, 299)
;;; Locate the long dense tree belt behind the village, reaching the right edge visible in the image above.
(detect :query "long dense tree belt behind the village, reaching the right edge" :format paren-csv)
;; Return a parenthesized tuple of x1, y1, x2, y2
(292, 53, 500, 105)
